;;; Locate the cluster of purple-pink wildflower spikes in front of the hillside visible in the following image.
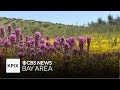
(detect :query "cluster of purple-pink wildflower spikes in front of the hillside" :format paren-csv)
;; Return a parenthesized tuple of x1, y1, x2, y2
(0, 25, 91, 59)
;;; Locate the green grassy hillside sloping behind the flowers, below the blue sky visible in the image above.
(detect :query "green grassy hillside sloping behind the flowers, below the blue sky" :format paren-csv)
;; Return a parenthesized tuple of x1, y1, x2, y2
(0, 17, 120, 38)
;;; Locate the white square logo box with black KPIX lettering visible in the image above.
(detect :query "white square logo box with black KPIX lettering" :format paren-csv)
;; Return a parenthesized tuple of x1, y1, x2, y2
(6, 59, 20, 73)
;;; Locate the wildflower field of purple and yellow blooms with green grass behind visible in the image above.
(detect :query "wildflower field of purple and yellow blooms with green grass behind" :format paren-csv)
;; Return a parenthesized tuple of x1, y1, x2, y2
(0, 17, 120, 78)
